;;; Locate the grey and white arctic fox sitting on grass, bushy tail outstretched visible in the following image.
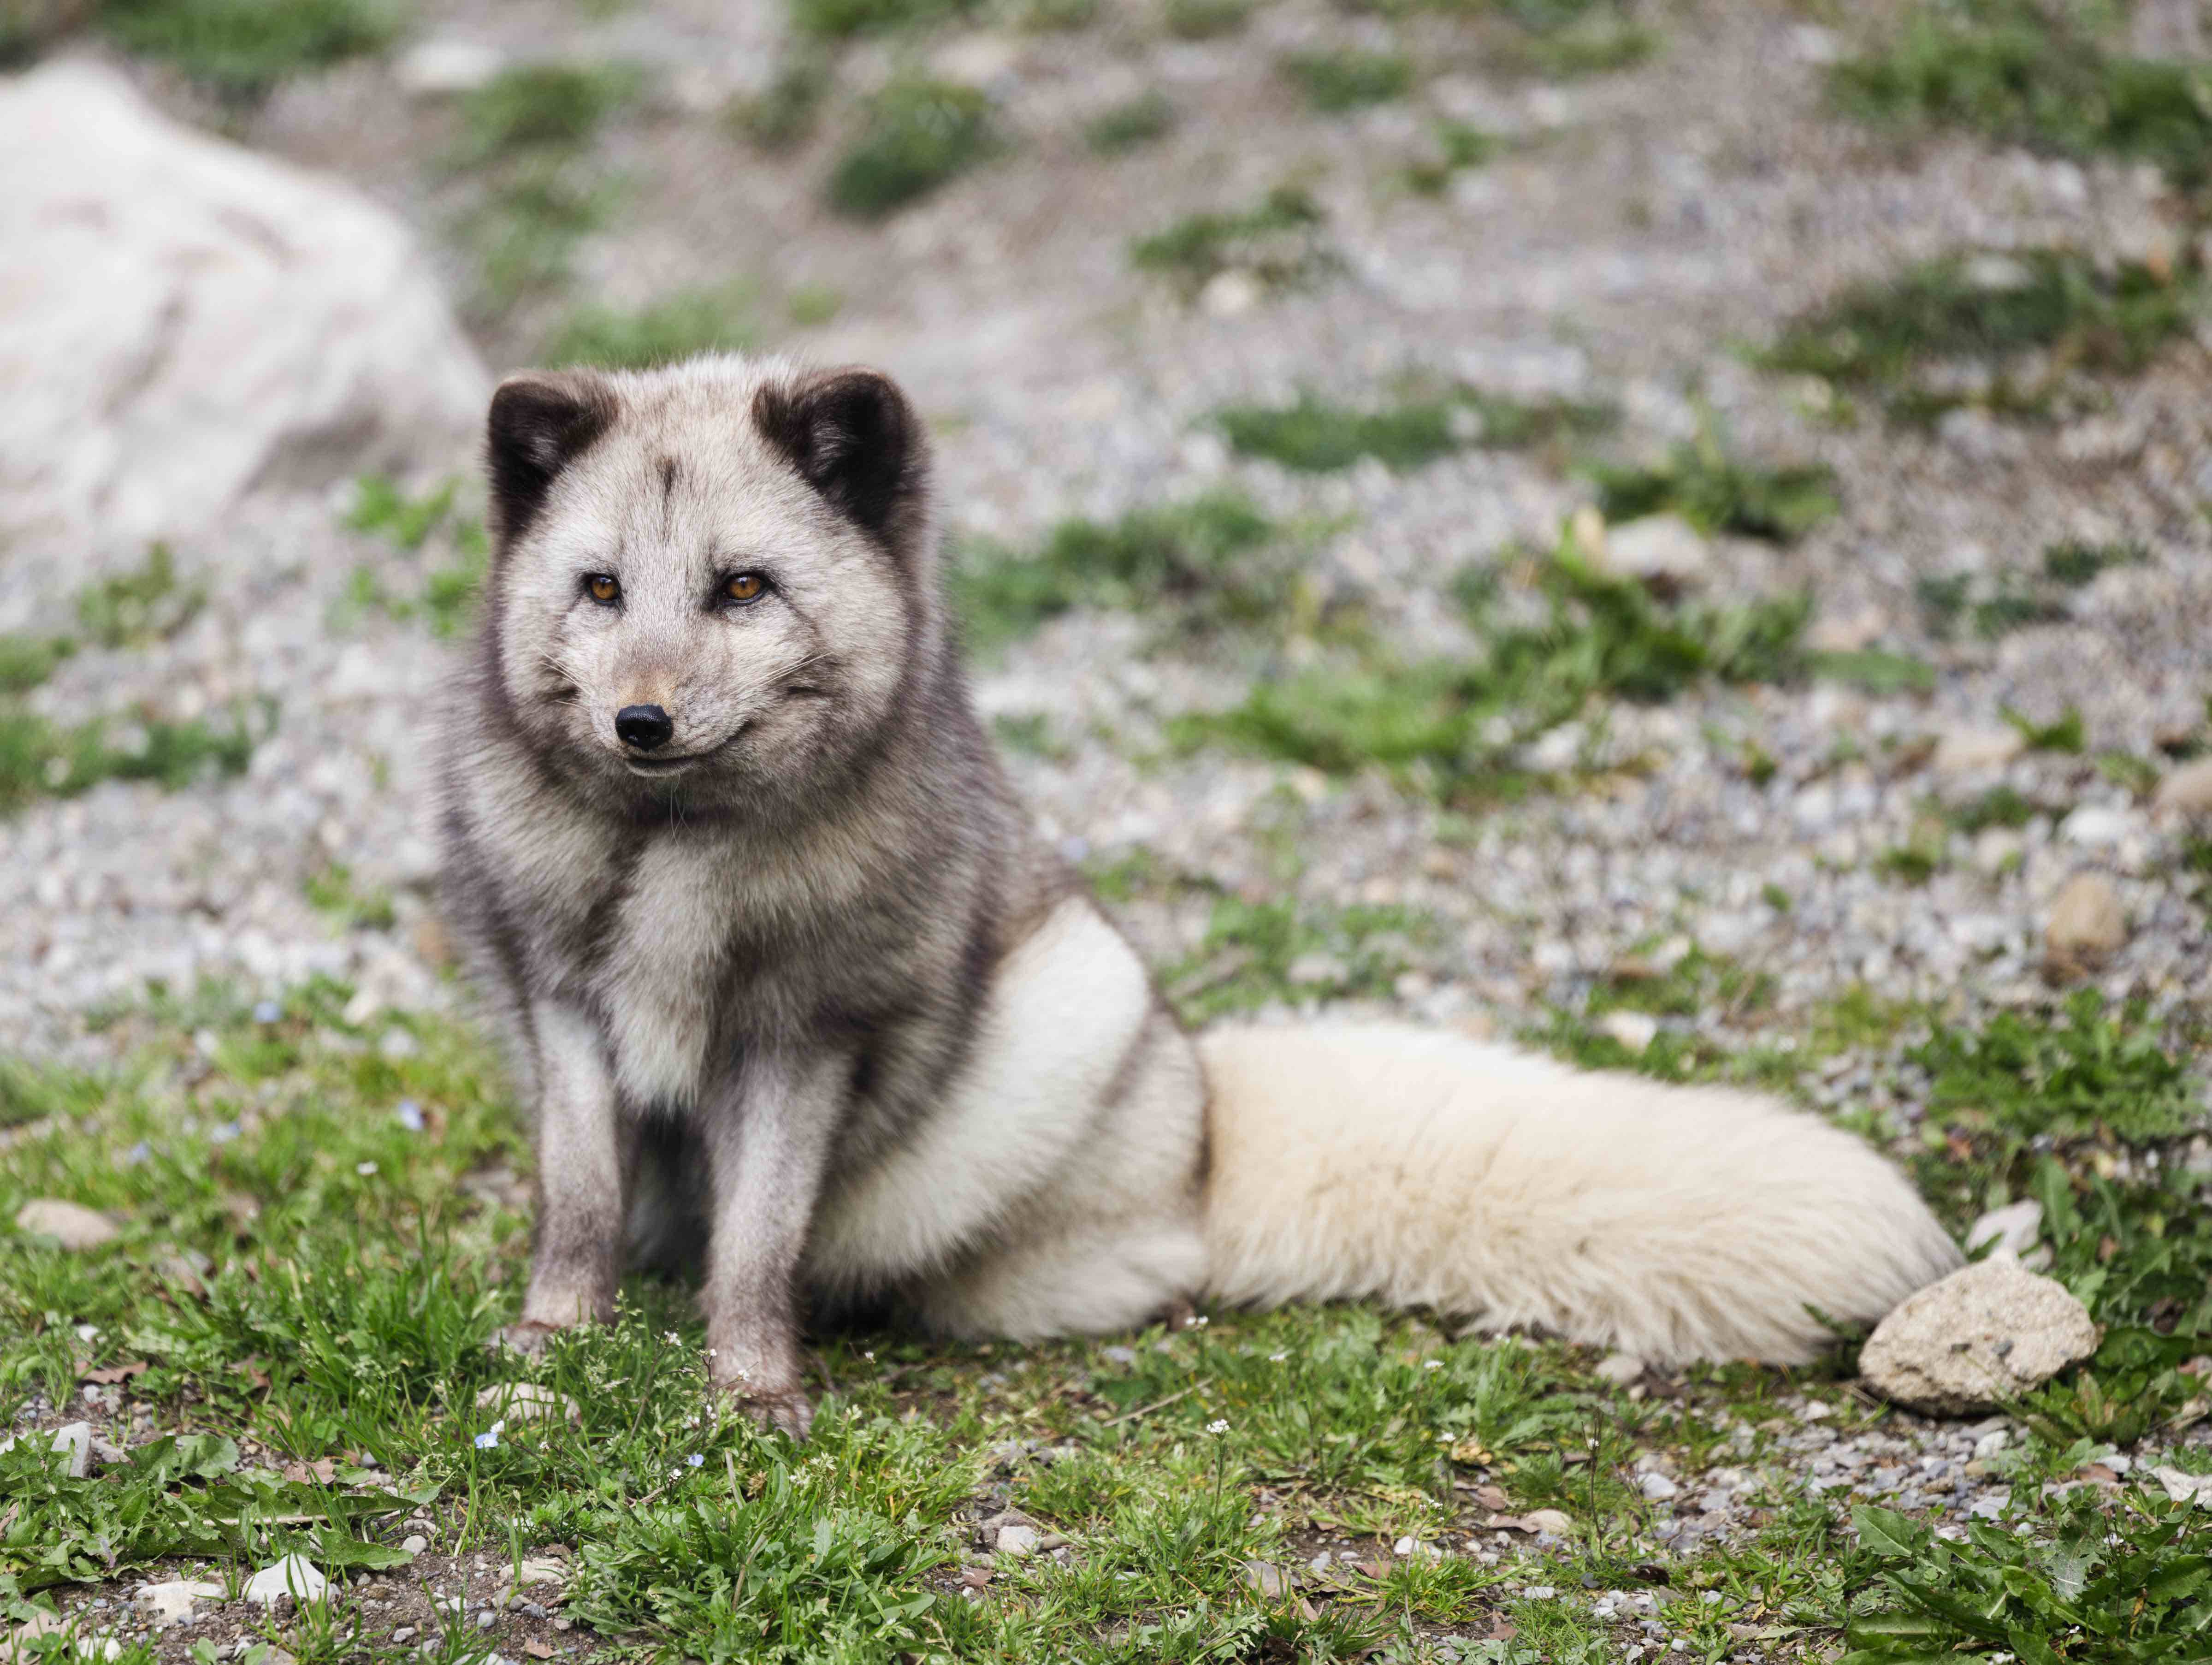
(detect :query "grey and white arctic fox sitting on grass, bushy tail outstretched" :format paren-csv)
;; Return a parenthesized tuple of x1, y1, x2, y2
(440, 358, 1960, 1437)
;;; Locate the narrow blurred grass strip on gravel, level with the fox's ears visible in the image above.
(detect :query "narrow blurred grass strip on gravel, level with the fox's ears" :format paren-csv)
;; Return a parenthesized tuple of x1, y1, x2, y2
(1214, 387, 1613, 473)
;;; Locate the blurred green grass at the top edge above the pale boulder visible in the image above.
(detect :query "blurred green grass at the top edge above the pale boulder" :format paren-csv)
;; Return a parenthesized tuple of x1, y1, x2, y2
(97, 0, 409, 104)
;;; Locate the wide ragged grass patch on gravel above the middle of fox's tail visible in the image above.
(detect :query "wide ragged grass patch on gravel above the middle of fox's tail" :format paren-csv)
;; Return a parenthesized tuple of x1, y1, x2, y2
(1170, 528, 1810, 800)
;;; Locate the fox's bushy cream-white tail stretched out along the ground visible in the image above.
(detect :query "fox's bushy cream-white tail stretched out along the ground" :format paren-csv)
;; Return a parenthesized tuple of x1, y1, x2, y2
(1199, 1024, 1960, 1364)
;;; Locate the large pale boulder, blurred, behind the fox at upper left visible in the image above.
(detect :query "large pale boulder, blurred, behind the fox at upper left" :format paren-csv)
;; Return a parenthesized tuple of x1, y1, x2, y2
(0, 62, 489, 566)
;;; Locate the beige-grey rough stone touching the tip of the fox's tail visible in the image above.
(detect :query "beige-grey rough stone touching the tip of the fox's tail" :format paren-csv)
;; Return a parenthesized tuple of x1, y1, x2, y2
(1858, 1260, 2097, 1415)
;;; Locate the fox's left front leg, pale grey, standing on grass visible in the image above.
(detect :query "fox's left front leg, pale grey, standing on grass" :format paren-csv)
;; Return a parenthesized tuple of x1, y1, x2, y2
(500, 1001, 637, 1353)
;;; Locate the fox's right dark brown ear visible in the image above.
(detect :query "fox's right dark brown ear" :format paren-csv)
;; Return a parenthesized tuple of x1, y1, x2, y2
(752, 369, 929, 542)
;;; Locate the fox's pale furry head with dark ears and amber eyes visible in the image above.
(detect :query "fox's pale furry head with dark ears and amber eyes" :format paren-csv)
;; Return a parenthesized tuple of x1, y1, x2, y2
(487, 358, 942, 809)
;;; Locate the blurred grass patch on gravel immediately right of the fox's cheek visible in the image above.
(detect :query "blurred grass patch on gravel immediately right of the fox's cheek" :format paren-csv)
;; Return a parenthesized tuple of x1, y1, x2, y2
(953, 491, 1292, 650)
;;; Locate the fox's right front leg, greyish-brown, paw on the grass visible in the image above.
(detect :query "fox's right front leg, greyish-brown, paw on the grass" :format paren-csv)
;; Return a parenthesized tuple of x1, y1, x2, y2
(701, 1053, 852, 1440)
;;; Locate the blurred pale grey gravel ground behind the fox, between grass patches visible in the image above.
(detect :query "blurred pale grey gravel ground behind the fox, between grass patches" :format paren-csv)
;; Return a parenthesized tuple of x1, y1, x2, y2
(0, 5, 2212, 1053)
